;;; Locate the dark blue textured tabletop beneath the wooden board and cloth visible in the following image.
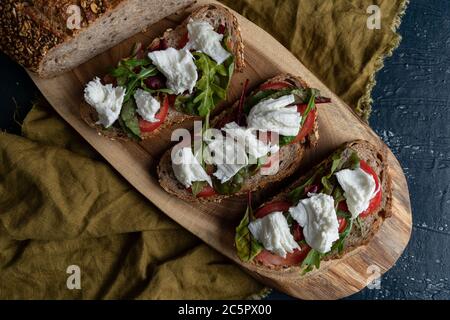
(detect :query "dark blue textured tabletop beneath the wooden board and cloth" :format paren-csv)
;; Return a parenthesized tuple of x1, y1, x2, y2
(0, 0, 450, 299)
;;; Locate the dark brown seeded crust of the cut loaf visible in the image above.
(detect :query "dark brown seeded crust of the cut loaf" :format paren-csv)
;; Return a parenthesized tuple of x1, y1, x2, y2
(0, 0, 194, 77)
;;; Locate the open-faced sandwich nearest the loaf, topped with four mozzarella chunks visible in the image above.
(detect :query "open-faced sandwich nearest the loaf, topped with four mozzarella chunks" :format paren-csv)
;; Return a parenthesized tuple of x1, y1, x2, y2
(81, 5, 244, 139)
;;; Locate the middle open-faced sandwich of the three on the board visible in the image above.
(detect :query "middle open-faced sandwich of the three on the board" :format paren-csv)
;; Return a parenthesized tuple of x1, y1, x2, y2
(158, 74, 329, 201)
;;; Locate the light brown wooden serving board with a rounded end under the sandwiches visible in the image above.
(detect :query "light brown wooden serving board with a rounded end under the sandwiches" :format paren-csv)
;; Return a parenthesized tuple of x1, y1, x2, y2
(30, 1, 412, 299)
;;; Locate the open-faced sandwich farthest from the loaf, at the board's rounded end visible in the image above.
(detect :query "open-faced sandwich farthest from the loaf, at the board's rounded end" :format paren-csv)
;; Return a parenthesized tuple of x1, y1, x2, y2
(235, 140, 391, 272)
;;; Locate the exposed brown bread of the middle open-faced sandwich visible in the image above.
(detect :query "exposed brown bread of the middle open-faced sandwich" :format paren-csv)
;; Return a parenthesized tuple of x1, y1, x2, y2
(158, 74, 319, 202)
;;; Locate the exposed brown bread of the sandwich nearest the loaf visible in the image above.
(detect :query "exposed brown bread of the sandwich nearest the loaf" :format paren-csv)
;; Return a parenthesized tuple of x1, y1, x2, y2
(80, 4, 245, 140)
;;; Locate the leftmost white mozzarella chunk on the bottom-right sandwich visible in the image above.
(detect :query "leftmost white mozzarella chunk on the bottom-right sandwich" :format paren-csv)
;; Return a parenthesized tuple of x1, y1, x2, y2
(248, 212, 299, 258)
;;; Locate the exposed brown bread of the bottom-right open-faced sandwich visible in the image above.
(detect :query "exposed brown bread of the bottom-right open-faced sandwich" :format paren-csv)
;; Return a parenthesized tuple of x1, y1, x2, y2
(248, 140, 392, 270)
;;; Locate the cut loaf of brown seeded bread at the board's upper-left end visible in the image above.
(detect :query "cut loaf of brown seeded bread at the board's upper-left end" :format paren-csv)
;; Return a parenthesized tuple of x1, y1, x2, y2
(0, 0, 194, 77)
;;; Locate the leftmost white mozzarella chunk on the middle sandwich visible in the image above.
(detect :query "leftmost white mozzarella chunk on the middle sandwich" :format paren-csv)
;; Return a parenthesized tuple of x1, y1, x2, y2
(172, 147, 212, 188)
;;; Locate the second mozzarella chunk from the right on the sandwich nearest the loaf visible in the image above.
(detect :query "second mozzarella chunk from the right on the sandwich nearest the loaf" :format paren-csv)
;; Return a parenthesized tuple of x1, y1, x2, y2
(148, 48, 198, 94)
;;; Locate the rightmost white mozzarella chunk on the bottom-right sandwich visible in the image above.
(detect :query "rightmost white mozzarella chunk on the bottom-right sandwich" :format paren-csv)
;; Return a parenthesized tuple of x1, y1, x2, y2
(336, 168, 378, 218)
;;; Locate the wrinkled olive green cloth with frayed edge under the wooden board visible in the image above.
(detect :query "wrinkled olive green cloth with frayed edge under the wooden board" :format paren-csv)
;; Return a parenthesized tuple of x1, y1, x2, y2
(0, 0, 405, 299)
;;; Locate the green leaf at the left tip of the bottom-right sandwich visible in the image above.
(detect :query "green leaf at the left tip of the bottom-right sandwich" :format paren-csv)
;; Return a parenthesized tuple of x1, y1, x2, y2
(234, 205, 264, 262)
